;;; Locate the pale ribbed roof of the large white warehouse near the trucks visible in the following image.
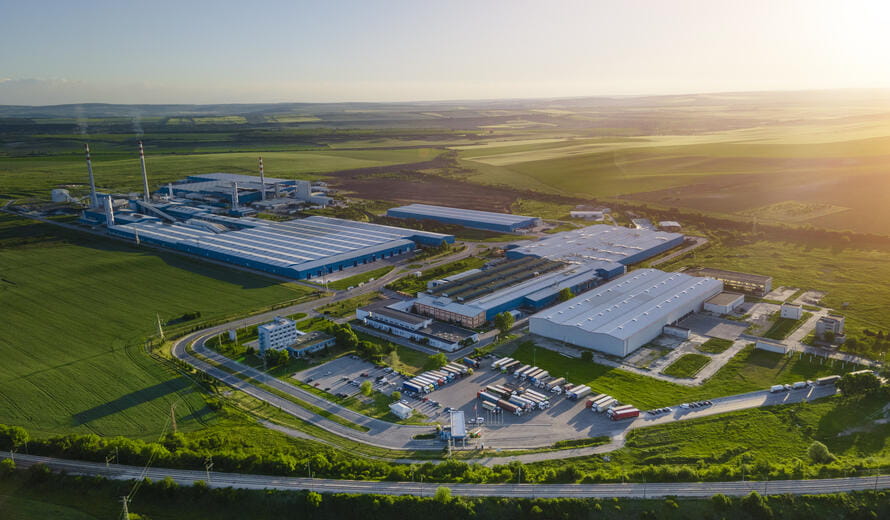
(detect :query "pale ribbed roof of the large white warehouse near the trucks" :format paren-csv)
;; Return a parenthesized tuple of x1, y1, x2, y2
(531, 269, 723, 340)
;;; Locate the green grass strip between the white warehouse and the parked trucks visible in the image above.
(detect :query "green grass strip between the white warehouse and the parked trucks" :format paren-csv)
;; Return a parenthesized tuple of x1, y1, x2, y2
(511, 341, 859, 410)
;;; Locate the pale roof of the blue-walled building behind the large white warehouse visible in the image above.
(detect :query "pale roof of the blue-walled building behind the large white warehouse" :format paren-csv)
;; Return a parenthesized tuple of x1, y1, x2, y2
(508, 224, 683, 265)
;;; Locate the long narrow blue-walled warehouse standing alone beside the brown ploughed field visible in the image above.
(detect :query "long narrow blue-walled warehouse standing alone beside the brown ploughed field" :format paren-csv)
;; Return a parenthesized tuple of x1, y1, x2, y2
(386, 204, 541, 233)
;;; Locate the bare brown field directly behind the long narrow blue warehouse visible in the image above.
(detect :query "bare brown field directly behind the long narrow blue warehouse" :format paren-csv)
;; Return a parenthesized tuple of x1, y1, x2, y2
(328, 157, 584, 213)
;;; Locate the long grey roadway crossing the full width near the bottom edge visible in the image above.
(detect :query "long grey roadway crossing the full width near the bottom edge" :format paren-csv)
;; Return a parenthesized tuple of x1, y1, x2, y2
(0, 452, 890, 498)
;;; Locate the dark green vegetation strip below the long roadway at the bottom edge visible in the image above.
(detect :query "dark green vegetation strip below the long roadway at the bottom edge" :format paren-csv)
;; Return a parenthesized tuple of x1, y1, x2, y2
(0, 467, 890, 520)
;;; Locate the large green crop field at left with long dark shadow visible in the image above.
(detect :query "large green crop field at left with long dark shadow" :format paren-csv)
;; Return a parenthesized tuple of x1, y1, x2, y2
(0, 215, 310, 438)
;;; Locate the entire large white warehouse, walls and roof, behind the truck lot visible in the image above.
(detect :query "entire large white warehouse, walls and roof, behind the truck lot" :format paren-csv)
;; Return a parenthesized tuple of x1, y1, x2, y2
(529, 269, 723, 357)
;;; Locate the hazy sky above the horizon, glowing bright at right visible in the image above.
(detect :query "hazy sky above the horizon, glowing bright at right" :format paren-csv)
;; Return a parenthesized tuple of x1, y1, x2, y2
(0, 0, 890, 105)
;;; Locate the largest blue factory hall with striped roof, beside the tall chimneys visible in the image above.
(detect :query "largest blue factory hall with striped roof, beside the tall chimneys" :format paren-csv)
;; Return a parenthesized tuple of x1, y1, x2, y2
(108, 209, 454, 279)
